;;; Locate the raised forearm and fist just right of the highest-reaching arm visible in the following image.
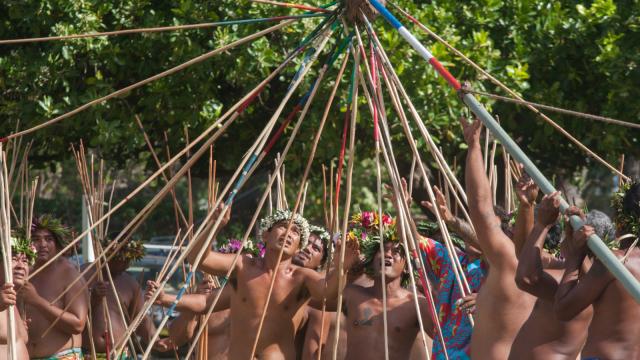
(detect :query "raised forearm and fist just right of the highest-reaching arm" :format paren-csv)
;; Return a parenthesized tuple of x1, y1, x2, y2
(507, 171, 539, 257)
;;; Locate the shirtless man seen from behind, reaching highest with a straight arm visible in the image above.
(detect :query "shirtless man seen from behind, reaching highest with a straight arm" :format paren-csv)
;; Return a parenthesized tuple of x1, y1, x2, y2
(460, 118, 535, 360)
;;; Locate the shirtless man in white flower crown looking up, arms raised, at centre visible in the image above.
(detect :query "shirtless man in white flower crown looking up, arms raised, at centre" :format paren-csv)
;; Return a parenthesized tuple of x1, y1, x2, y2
(187, 210, 357, 359)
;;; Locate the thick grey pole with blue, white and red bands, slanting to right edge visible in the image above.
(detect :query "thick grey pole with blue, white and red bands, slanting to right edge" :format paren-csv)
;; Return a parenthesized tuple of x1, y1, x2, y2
(369, 0, 640, 303)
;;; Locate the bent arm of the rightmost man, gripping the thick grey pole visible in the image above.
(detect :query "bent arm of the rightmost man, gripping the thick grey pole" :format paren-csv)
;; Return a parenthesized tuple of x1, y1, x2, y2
(554, 225, 614, 321)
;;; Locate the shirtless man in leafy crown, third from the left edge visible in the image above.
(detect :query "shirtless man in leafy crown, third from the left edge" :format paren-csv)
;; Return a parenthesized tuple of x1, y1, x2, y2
(83, 241, 162, 359)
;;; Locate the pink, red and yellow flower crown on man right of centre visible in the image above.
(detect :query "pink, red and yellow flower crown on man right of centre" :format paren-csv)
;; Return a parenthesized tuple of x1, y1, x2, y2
(347, 211, 398, 266)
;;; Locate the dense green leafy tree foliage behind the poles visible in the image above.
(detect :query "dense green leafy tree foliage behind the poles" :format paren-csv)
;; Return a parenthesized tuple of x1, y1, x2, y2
(0, 0, 640, 242)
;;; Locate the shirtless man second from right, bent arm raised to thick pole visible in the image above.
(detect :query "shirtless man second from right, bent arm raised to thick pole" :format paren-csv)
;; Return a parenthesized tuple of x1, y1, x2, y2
(509, 193, 592, 360)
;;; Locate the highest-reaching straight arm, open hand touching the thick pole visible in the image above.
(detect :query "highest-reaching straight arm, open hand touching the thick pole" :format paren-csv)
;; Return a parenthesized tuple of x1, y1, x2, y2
(460, 118, 516, 269)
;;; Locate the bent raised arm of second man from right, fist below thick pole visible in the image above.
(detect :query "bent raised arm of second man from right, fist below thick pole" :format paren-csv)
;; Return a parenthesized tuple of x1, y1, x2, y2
(516, 192, 560, 302)
